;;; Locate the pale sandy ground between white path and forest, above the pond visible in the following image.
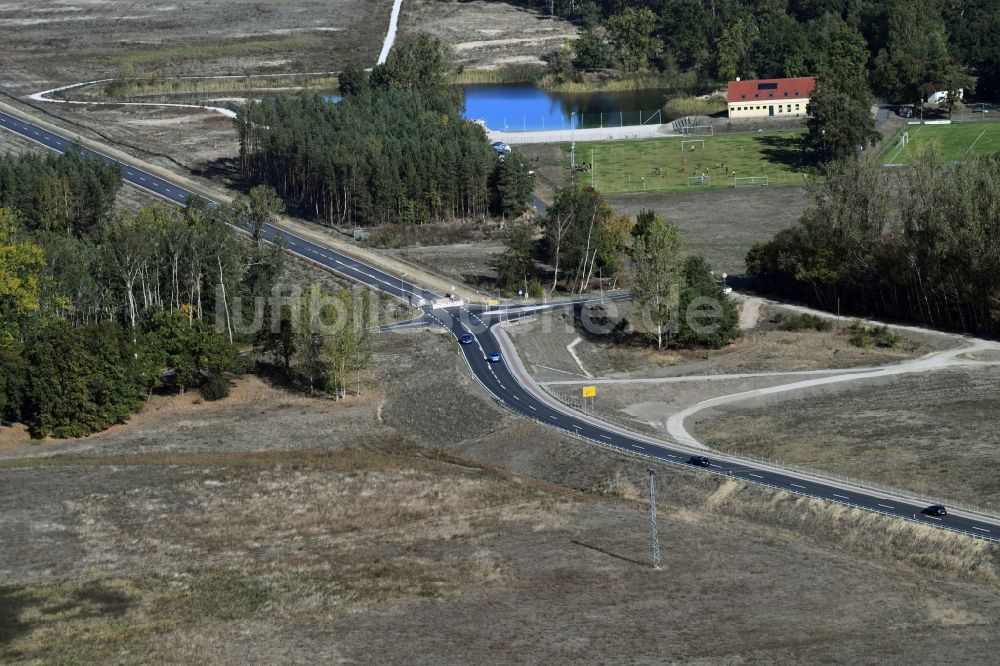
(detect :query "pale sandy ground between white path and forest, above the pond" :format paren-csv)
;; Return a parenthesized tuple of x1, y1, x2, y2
(399, 0, 578, 69)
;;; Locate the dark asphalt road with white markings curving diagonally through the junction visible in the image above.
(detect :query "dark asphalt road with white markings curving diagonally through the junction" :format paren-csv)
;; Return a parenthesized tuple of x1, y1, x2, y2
(0, 113, 1000, 540)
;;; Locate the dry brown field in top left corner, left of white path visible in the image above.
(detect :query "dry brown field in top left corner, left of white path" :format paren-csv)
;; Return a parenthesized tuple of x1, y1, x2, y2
(0, 0, 392, 94)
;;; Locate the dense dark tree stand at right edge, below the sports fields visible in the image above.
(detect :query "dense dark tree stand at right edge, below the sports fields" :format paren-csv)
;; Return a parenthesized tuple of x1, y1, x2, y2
(747, 148, 1000, 335)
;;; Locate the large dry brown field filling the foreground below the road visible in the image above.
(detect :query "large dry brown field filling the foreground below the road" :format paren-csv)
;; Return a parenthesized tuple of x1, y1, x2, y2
(0, 332, 1000, 663)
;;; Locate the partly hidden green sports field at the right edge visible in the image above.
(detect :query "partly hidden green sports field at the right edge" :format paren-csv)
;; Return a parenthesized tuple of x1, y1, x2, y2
(882, 123, 1000, 164)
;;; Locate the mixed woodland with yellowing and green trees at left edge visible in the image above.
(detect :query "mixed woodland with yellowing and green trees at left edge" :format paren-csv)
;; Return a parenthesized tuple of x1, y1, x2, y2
(0, 151, 371, 437)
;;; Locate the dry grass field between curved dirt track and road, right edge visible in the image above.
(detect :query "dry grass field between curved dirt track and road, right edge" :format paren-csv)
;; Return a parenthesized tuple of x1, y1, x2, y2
(689, 369, 1000, 510)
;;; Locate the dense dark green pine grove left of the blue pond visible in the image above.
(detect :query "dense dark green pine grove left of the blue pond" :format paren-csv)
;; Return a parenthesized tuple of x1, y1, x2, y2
(238, 36, 530, 224)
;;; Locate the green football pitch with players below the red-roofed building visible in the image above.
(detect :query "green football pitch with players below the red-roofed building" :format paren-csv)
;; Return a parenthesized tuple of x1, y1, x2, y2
(565, 131, 812, 194)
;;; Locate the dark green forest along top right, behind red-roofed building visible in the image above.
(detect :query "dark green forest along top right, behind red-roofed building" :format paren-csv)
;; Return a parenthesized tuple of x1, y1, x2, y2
(511, 0, 1000, 102)
